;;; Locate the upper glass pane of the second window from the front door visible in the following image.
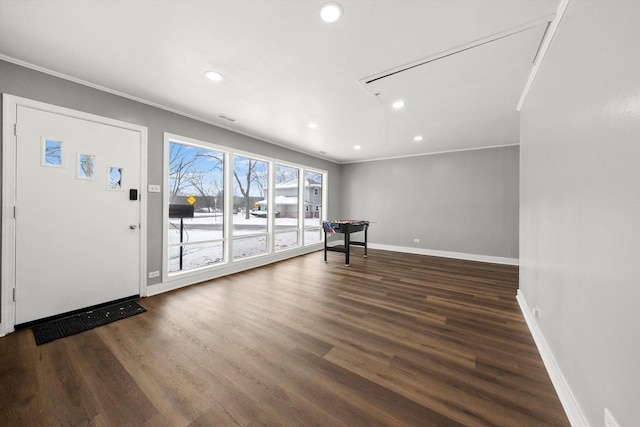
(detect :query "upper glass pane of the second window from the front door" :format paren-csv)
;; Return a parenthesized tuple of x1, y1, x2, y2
(233, 156, 269, 236)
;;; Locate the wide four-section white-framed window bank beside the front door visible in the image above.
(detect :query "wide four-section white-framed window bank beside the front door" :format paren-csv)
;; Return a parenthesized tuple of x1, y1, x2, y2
(165, 134, 326, 280)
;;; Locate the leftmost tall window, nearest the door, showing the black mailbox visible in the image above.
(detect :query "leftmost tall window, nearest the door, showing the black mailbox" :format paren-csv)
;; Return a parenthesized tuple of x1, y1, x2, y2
(168, 141, 224, 273)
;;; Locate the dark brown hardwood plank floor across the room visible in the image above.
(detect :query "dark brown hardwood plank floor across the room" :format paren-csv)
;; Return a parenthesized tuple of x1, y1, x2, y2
(0, 249, 569, 426)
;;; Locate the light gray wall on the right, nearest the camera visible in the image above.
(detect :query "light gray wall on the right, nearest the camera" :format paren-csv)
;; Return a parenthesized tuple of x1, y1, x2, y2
(520, 0, 640, 426)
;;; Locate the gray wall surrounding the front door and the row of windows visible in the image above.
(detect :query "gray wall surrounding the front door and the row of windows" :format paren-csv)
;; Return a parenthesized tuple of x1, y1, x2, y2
(0, 61, 341, 284)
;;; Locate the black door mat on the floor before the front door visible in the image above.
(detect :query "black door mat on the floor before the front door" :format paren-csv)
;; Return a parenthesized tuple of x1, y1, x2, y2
(31, 301, 147, 345)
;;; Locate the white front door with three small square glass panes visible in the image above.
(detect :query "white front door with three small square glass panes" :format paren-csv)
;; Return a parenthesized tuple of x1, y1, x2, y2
(15, 105, 142, 324)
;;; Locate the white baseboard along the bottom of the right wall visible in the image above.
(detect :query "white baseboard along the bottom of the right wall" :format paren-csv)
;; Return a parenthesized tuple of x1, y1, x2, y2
(516, 289, 589, 427)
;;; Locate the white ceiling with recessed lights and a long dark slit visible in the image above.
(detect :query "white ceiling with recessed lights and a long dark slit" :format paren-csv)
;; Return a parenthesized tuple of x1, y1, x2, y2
(0, 0, 560, 163)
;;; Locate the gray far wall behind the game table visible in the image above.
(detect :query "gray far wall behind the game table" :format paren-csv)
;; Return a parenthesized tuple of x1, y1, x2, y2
(341, 146, 519, 259)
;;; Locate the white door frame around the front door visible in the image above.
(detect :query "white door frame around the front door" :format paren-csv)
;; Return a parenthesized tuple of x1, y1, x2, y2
(0, 94, 147, 336)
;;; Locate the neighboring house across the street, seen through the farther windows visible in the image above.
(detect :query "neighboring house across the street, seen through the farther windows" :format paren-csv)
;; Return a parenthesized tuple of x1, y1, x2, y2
(252, 178, 322, 218)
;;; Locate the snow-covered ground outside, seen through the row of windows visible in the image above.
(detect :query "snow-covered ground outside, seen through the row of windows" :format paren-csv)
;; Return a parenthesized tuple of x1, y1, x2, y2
(169, 213, 322, 273)
